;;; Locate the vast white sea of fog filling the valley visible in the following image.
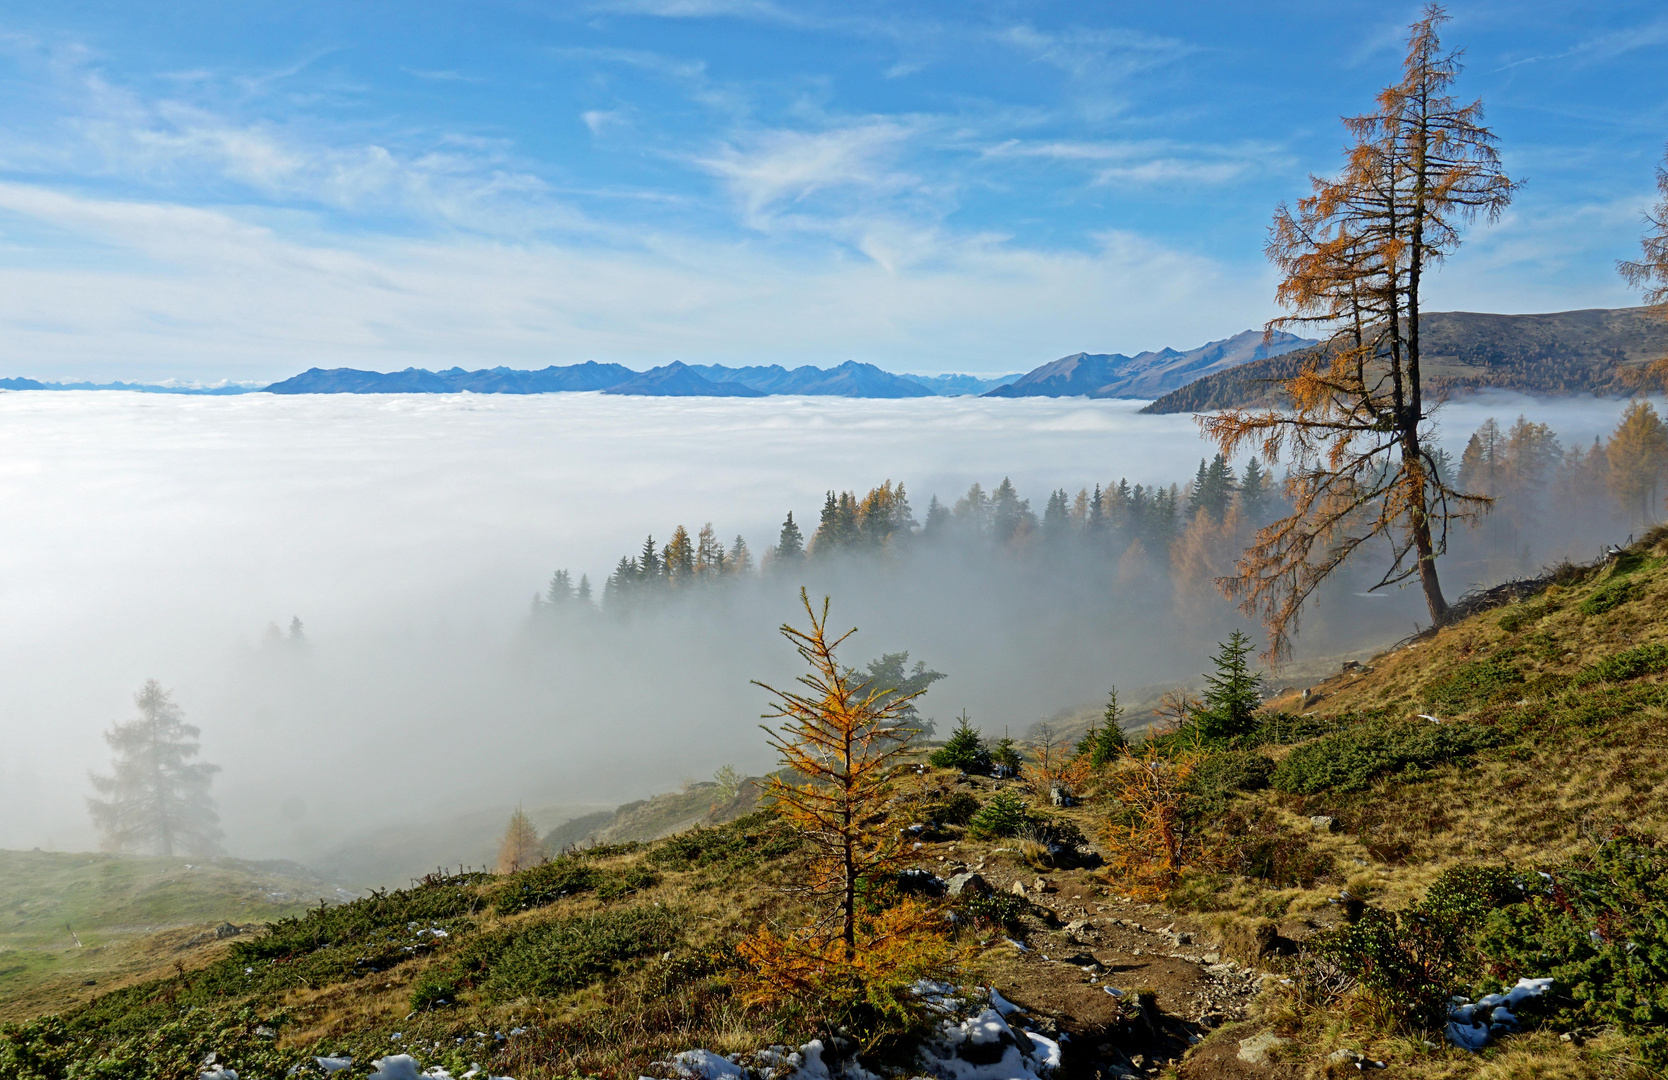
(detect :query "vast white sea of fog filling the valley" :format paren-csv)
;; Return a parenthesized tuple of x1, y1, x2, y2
(0, 392, 1641, 858)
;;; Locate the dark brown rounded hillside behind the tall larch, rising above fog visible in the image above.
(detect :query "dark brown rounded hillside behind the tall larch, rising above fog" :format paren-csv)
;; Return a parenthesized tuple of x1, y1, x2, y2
(1143, 307, 1668, 412)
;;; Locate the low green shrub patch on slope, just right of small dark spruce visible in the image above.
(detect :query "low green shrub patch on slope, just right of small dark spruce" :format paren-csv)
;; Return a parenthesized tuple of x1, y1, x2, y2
(1269, 719, 1501, 795)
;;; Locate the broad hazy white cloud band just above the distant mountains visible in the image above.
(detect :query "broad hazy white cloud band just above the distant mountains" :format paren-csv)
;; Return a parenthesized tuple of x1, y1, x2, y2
(0, 184, 1269, 379)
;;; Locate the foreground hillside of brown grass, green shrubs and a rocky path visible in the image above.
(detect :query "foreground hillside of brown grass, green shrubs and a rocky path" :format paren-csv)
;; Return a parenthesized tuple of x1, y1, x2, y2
(13, 529, 1668, 1080)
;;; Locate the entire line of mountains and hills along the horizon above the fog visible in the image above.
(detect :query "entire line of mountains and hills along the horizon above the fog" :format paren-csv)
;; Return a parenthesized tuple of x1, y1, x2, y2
(13, 307, 1668, 412)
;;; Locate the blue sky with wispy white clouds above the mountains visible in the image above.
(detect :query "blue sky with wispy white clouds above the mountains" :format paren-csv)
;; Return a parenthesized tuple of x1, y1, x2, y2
(0, 0, 1668, 381)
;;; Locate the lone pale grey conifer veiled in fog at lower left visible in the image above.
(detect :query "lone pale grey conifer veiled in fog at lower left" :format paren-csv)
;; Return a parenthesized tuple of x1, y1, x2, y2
(87, 679, 222, 855)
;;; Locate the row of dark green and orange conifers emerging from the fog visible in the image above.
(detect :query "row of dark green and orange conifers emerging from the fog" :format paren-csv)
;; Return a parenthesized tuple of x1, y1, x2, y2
(534, 401, 1668, 616)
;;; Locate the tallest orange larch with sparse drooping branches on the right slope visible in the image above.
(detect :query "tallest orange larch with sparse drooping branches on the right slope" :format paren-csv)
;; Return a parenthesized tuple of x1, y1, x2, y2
(1201, 5, 1516, 658)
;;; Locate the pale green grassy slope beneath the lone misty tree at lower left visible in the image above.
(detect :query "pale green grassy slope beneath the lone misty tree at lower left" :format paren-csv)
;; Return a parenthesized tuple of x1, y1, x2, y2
(0, 851, 342, 1018)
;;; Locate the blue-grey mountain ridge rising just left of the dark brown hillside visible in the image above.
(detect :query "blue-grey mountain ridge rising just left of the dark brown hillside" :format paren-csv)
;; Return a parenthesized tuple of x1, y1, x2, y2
(984, 331, 1314, 399)
